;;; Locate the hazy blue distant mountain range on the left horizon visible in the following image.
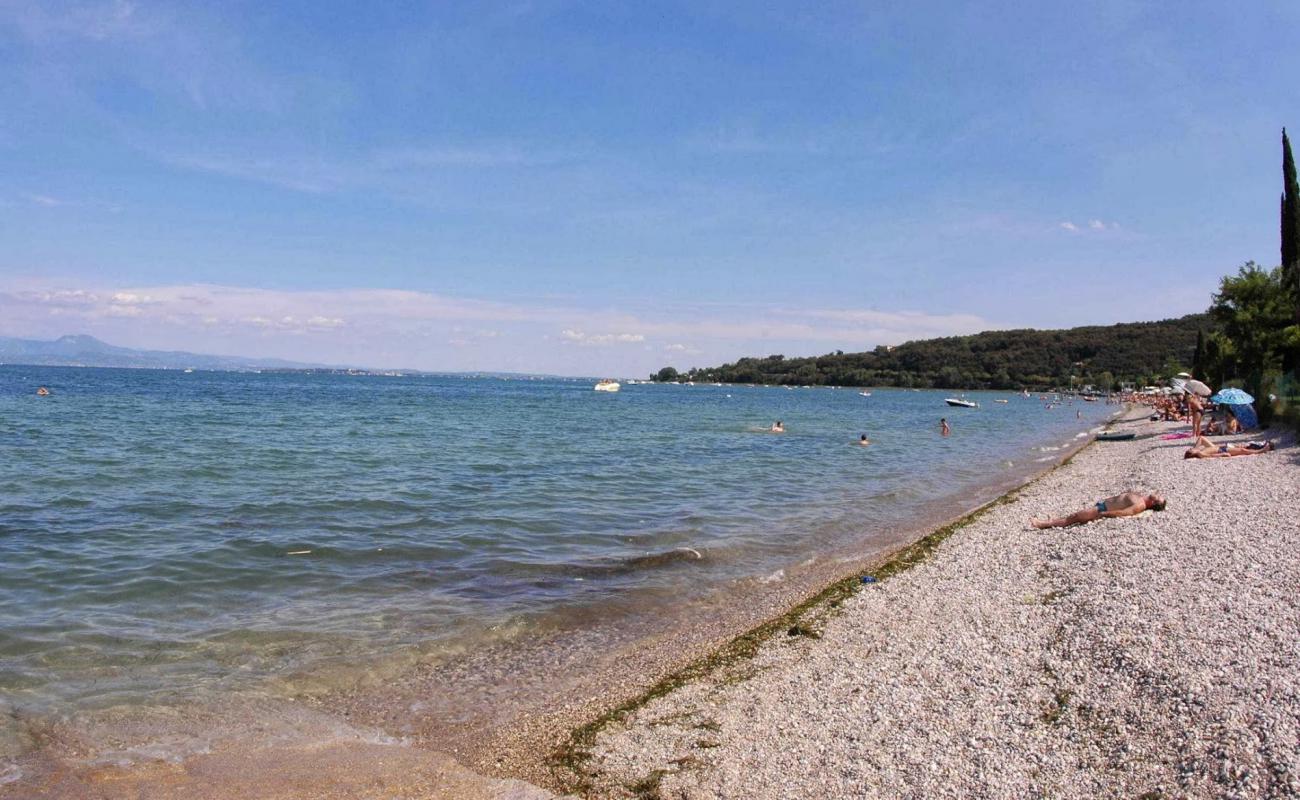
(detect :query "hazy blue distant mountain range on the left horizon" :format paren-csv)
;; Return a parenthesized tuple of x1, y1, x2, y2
(0, 334, 325, 369)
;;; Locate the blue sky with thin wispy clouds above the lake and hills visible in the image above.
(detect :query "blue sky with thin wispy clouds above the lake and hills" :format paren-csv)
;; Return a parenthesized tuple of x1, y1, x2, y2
(0, 0, 1300, 376)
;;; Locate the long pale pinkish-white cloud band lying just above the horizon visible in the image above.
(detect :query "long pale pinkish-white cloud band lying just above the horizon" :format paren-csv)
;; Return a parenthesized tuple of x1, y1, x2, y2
(0, 282, 992, 375)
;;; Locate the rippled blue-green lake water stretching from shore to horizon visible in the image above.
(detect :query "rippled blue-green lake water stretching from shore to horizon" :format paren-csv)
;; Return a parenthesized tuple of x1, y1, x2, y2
(0, 366, 1115, 714)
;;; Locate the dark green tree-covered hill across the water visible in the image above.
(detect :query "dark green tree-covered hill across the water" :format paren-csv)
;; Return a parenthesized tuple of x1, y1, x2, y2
(651, 313, 1213, 389)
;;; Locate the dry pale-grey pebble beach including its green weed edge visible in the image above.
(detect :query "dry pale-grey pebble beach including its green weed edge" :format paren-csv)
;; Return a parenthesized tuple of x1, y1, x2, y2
(555, 411, 1300, 799)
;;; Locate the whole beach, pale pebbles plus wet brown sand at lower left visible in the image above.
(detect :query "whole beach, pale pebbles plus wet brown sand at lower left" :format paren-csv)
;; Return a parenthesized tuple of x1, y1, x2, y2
(0, 410, 1300, 800)
